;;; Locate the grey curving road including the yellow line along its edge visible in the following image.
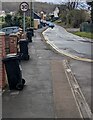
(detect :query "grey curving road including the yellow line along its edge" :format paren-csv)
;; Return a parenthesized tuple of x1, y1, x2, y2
(42, 26, 93, 62)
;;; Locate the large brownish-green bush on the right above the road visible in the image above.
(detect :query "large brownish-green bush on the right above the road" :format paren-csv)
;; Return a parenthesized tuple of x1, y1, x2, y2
(60, 9, 90, 28)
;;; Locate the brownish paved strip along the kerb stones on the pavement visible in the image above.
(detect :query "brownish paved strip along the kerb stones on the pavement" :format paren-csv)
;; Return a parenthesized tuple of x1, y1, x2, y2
(51, 60, 81, 118)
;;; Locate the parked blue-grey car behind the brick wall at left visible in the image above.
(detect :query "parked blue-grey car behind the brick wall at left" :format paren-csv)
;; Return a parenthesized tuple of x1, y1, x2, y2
(0, 26, 20, 35)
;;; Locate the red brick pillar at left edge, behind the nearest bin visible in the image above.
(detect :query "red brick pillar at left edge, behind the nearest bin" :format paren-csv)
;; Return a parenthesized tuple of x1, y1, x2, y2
(0, 32, 6, 88)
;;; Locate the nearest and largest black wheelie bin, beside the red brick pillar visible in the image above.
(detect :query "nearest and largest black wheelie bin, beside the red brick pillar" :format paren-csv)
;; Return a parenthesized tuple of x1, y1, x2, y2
(3, 54, 25, 90)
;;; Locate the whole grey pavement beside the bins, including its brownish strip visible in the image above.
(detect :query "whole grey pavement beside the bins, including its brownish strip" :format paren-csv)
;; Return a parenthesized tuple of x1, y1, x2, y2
(2, 30, 80, 120)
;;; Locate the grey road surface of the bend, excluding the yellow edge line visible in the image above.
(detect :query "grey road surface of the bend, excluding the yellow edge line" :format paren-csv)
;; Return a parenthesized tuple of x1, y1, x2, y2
(45, 25, 93, 59)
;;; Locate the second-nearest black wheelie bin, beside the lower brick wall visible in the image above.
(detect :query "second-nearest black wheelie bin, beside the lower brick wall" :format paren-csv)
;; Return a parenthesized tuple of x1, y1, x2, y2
(18, 39, 29, 60)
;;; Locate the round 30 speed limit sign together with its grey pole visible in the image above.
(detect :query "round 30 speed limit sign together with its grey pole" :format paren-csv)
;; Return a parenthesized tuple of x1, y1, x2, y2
(20, 2, 29, 34)
